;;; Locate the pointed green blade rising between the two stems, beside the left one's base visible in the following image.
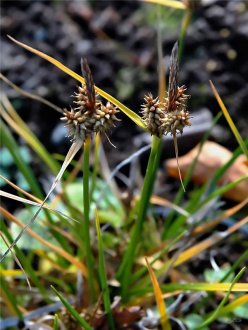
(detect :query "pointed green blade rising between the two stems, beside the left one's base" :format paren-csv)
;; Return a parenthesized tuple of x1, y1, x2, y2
(96, 211, 115, 330)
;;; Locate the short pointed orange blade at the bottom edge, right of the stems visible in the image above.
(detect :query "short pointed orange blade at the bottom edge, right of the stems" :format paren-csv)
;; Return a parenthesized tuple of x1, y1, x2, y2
(145, 258, 171, 330)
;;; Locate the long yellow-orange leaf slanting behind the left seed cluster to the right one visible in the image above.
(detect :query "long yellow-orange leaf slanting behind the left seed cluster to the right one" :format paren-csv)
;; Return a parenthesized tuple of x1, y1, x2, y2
(8, 36, 145, 129)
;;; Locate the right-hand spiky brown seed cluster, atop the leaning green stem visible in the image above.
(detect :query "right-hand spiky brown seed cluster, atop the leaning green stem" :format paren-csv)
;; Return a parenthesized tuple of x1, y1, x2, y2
(141, 86, 191, 137)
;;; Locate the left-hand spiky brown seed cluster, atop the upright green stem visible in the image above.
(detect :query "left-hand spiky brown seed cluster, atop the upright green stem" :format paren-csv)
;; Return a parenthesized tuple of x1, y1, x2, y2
(61, 86, 119, 141)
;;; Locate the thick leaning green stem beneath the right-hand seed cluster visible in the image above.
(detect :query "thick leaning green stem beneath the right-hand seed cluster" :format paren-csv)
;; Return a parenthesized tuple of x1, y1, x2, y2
(118, 135, 161, 301)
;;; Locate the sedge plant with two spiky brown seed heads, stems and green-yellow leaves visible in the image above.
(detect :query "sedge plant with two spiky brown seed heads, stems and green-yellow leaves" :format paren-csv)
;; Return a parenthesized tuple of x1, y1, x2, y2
(1, 1, 248, 329)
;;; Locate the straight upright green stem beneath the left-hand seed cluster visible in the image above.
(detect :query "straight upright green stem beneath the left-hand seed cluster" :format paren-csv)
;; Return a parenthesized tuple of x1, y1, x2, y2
(82, 138, 96, 302)
